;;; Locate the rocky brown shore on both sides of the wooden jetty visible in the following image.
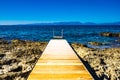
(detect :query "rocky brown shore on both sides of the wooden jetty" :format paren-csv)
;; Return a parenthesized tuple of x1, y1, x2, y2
(0, 40, 120, 80)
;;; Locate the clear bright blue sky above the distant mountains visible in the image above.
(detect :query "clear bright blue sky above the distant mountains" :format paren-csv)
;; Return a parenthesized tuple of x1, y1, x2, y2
(0, 0, 120, 24)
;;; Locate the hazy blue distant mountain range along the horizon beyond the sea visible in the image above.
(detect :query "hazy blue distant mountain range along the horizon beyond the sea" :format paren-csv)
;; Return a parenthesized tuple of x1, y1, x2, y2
(0, 22, 120, 25)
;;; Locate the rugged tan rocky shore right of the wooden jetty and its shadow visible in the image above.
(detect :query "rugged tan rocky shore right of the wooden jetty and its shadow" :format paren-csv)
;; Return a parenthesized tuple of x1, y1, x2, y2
(71, 43, 120, 80)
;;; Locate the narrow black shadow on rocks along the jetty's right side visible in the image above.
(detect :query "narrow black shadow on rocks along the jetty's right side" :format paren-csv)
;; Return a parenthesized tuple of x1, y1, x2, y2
(70, 45, 101, 80)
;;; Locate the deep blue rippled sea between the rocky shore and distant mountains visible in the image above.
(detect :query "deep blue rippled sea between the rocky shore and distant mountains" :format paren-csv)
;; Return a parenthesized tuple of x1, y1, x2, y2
(0, 25, 120, 48)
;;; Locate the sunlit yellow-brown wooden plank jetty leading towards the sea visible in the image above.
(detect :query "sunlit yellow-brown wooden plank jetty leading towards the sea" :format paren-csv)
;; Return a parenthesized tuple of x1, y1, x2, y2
(28, 39, 93, 80)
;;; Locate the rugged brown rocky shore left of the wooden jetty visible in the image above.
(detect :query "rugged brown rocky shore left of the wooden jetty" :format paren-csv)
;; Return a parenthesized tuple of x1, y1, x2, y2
(0, 40, 47, 80)
